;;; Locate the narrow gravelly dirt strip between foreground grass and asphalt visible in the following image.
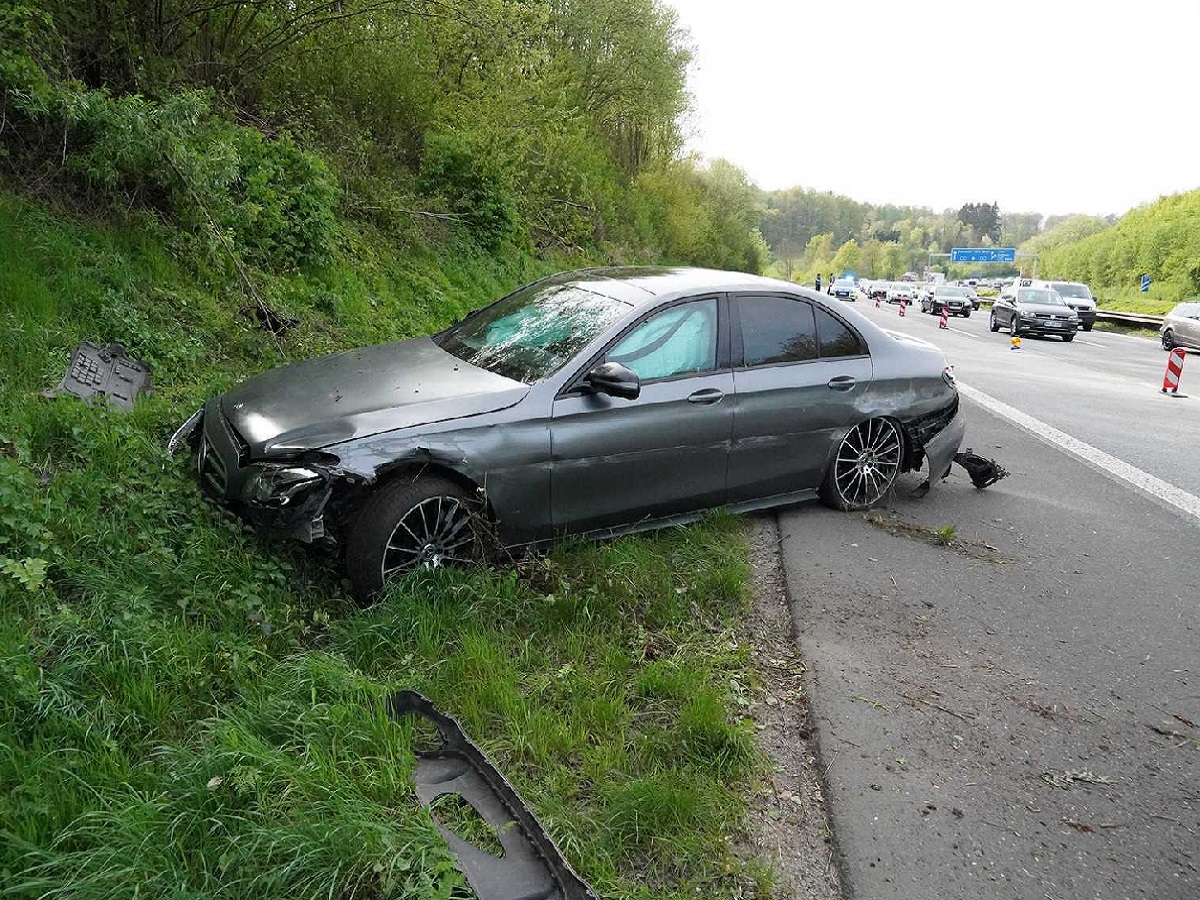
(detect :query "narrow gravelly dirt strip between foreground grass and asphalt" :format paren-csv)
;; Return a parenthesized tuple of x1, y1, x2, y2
(746, 515, 842, 900)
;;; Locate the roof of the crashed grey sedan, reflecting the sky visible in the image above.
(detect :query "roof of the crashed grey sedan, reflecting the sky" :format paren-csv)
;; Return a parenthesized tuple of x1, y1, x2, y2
(541, 265, 799, 306)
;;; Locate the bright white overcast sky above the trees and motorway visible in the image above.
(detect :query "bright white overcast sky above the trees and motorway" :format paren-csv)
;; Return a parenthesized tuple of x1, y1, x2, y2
(664, 0, 1200, 215)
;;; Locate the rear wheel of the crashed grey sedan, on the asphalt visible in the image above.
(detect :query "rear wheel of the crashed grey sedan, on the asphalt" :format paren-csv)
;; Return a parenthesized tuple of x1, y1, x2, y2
(818, 418, 904, 512)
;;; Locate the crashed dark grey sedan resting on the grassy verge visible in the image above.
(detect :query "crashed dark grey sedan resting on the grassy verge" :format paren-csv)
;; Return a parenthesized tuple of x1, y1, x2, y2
(172, 268, 964, 600)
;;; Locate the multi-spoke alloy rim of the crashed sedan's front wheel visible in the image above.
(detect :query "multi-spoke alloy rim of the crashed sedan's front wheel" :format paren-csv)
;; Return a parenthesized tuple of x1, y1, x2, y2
(382, 496, 475, 580)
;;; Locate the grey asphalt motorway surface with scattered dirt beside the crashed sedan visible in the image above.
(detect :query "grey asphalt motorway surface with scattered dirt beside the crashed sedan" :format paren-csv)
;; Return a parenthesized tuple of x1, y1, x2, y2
(780, 292, 1200, 900)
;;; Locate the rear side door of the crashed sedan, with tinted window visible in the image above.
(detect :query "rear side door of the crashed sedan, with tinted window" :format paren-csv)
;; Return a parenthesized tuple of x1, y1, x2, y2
(728, 294, 871, 503)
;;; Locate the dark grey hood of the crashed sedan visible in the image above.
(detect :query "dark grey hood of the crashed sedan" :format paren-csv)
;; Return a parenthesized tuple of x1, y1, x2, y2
(221, 337, 529, 458)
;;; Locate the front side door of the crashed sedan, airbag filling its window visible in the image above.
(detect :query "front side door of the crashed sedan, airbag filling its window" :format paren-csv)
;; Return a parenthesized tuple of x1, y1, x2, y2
(551, 295, 733, 533)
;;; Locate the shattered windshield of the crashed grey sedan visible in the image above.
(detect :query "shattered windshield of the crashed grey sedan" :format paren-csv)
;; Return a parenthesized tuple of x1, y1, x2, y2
(433, 282, 630, 384)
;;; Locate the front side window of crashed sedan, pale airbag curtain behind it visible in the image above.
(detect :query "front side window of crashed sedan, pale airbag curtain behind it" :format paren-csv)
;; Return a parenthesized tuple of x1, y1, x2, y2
(605, 299, 716, 382)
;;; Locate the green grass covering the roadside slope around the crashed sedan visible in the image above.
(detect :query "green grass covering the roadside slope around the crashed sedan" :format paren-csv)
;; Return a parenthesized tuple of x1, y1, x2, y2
(0, 196, 763, 900)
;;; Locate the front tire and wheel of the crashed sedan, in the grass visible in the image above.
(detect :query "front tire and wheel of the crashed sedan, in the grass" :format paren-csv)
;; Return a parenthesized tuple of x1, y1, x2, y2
(346, 475, 484, 604)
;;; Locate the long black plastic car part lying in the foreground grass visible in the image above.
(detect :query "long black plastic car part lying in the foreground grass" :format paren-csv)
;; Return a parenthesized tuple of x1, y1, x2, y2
(388, 691, 599, 900)
